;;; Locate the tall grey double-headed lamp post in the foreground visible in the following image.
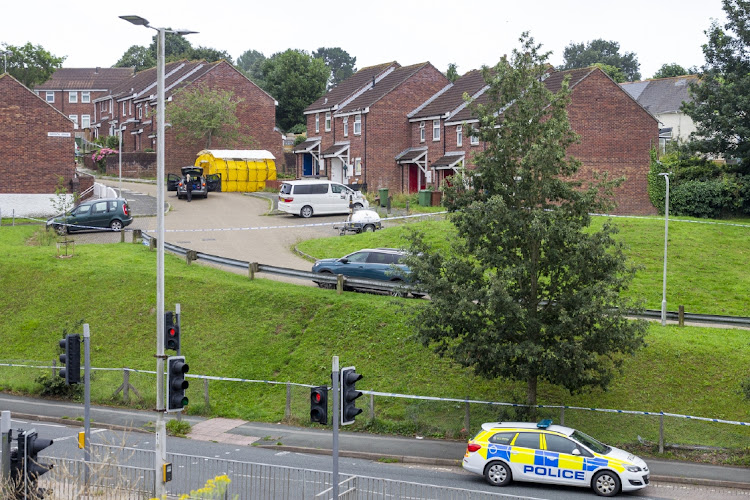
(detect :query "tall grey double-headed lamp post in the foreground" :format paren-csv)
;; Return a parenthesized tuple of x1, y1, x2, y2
(120, 16, 197, 498)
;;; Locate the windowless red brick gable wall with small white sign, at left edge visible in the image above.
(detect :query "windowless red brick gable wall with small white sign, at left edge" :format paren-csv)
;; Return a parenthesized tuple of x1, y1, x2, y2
(0, 74, 75, 194)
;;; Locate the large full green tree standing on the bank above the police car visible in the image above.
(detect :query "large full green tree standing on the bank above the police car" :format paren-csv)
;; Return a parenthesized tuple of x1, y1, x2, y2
(407, 33, 646, 418)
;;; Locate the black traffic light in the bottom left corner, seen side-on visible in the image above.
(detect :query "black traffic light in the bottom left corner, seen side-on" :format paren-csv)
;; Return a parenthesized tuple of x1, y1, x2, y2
(10, 430, 53, 498)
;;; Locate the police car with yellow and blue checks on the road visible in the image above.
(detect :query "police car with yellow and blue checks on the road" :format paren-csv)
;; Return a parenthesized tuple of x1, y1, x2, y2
(463, 420, 649, 497)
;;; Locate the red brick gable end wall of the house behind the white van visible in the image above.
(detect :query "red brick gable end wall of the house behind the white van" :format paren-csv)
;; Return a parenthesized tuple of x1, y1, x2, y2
(362, 64, 448, 192)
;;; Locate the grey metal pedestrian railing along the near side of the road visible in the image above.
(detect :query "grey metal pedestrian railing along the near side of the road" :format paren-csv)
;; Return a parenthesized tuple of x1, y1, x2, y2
(39, 444, 528, 500)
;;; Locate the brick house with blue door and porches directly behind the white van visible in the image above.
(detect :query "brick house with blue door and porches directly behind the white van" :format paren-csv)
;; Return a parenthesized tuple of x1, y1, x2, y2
(295, 62, 448, 191)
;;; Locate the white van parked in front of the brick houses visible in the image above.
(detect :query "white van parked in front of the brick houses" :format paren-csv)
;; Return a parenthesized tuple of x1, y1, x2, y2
(279, 179, 369, 218)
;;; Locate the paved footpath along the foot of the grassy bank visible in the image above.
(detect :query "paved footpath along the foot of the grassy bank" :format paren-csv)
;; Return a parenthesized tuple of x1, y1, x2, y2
(0, 394, 750, 490)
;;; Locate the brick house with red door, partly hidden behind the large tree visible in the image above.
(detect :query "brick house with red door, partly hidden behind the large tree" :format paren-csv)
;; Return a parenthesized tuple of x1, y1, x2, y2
(406, 68, 659, 214)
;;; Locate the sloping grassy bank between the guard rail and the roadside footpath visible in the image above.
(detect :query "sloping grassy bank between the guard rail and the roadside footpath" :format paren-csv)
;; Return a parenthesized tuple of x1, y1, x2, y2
(0, 227, 750, 462)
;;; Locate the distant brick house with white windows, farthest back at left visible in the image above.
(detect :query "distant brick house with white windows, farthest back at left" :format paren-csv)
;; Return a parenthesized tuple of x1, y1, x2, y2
(34, 68, 135, 139)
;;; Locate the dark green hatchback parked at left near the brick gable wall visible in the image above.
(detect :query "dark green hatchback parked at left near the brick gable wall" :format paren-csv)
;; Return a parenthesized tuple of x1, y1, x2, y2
(47, 198, 133, 235)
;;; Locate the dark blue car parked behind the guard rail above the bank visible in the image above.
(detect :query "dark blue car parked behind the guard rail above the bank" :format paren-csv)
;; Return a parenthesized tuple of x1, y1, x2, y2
(312, 248, 424, 297)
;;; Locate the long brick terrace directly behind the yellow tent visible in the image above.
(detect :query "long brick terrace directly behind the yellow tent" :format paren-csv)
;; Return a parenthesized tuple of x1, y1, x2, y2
(92, 60, 284, 176)
